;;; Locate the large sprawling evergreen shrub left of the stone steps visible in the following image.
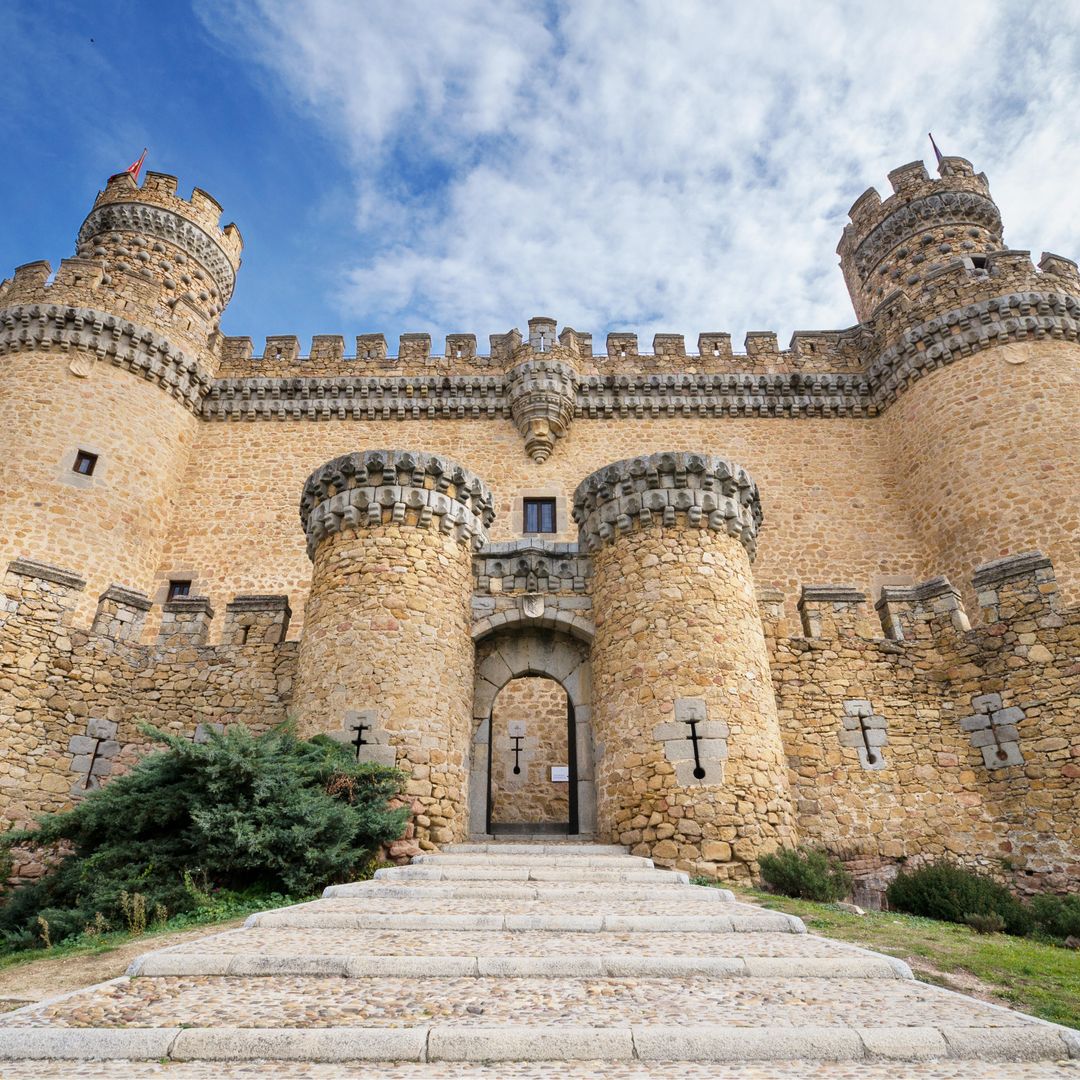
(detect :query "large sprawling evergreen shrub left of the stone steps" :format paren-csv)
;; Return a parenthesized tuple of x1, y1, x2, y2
(0, 725, 408, 949)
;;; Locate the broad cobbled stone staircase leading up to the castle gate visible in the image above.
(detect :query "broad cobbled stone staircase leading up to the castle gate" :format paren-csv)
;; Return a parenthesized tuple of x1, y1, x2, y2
(0, 841, 1080, 1080)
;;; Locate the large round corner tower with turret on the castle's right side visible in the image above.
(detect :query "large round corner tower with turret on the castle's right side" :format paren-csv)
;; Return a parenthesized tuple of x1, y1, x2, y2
(838, 158, 1080, 613)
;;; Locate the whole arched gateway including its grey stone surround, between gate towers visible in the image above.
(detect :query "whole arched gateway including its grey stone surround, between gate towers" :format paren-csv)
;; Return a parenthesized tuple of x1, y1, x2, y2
(469, 624, 596, 836)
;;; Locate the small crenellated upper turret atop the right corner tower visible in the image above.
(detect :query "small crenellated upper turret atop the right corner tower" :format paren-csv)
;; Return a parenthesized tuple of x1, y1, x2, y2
(836, 158, 1004, 322)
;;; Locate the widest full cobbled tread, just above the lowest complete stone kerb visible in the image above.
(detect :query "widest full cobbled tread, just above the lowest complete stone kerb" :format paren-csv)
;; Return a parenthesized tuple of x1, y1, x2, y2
(0, 976, 1038, 1027)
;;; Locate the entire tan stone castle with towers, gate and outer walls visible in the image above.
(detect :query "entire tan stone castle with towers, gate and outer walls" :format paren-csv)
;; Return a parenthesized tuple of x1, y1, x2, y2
(0, 150, 1080, 896)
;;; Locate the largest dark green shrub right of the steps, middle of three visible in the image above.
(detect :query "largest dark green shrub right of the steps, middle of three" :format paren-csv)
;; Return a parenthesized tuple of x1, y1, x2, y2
(886, 860, 1032, 934)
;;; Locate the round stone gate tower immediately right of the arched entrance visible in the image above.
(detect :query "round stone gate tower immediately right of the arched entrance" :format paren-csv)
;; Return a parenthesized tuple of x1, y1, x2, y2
(573, 454, 795, 879)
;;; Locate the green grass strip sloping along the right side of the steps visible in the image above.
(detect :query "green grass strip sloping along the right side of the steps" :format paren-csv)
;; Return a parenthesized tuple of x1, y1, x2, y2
(733, 888, 1080, 1028)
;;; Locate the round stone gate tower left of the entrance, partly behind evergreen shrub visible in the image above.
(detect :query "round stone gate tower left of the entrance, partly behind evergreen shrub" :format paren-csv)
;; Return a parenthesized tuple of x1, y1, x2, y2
(295, 450, 495, 849)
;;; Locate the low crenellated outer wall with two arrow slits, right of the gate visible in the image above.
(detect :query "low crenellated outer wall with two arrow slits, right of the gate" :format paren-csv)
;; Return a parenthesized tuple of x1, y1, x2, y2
(764, 558, 1080, 893)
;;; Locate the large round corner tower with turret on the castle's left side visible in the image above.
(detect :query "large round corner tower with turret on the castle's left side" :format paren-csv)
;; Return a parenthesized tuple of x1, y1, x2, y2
(0, 173, 241, 617)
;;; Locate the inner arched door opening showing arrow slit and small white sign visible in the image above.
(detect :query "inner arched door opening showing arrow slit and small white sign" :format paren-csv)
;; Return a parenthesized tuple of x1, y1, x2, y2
(486, 675, 578, 836)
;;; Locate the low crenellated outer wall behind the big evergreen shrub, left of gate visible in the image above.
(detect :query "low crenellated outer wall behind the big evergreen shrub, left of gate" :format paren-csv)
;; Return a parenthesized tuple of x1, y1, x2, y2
(0, 563, 297, 838)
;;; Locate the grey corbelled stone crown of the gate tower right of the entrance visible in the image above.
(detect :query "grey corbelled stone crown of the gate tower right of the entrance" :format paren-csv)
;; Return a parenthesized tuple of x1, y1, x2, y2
(573, 453, 761, 558)
